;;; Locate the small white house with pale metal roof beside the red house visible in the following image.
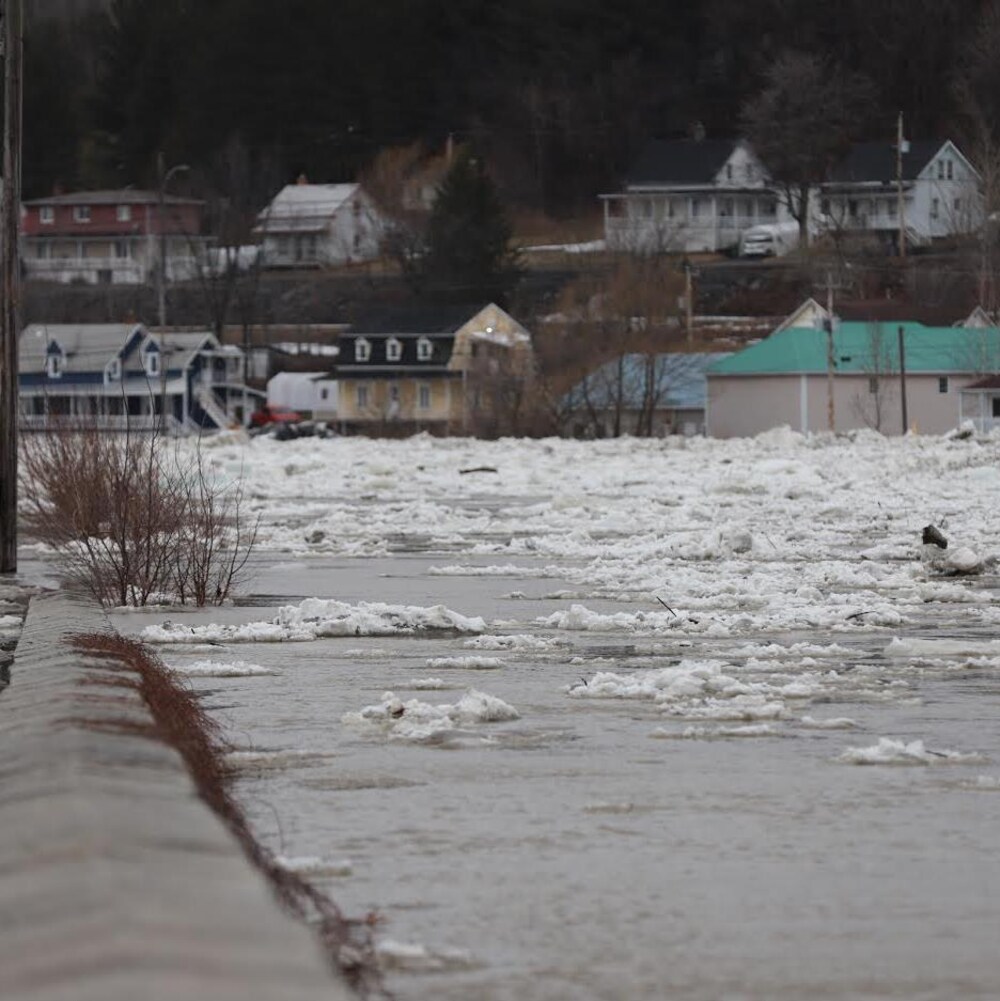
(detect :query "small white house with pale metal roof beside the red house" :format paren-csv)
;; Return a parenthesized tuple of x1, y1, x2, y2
(253, 182, 385, 267)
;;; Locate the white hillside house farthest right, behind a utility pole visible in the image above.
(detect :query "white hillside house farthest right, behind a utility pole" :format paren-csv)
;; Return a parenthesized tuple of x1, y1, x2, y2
(815, 139, 983, 245)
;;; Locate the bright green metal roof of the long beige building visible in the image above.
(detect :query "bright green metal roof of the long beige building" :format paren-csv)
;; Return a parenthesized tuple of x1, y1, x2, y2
(708, 322, 1000, 375)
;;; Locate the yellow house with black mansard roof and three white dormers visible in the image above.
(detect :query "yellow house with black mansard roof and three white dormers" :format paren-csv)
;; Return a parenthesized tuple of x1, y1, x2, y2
(337, 303, 532, 434)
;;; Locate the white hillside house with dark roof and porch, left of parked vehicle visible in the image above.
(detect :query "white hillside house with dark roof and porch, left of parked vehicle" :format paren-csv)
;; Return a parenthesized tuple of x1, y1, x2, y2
(601, 139, 791, 253)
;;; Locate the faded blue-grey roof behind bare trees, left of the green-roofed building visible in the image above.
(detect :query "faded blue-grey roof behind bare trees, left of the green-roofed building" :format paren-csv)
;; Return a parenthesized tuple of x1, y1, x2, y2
(564, 351, 729, 410)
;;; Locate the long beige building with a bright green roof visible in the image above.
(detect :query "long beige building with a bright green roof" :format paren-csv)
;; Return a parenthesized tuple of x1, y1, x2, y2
(706, 320, 1000, 437)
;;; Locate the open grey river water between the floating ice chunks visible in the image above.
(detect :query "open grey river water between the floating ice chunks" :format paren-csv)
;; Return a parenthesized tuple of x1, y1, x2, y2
(114, 553, 1000, 1001)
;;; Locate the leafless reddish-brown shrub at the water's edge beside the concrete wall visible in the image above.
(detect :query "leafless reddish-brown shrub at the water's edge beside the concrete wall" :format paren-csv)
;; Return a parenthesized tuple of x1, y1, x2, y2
(21, 427, 257, 606)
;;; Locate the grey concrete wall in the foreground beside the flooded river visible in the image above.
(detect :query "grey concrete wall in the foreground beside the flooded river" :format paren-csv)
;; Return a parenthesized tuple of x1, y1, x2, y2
(0, 594, 353, 1001)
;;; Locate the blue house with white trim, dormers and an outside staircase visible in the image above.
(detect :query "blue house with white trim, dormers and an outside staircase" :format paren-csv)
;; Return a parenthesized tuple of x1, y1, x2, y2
(18, 323, 263, 434)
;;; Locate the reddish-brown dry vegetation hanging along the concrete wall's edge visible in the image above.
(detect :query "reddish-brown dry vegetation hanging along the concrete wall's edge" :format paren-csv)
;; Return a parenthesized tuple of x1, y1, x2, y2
(73, 633, 389, 997)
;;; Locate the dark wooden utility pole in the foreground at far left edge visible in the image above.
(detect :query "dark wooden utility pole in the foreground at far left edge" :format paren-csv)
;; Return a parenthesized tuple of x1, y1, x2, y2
(0, 0, 24, 574)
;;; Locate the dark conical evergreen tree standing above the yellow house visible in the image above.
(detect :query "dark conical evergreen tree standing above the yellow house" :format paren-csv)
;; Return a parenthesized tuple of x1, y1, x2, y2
(423, 148, 517, 298)
